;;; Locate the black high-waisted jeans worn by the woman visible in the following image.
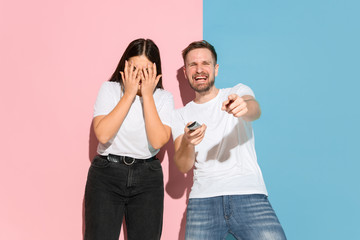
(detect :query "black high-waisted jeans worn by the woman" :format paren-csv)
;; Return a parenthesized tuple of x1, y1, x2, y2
(84, 156, 164, 240)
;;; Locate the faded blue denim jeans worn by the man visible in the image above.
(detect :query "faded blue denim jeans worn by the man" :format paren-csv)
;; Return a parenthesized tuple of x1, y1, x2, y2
(185, 194, 286, 240)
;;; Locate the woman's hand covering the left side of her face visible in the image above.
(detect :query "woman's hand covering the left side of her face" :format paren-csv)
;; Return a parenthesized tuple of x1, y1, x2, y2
(120, 61, 141, 97)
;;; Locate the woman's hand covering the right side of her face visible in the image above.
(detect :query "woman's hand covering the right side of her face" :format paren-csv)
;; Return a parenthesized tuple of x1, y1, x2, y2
(139, 63, 161, 96)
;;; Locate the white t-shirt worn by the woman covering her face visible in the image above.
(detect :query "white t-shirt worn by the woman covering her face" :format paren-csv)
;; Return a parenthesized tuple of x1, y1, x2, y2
(94, 82, 174, 159)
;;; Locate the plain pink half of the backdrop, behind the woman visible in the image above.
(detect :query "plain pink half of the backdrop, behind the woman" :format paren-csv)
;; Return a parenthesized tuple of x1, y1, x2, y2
(0, 0, 202, 240)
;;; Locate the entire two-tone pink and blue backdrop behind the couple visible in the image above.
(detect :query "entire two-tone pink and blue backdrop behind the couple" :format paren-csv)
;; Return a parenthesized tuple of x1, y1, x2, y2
(0, 0, 360, 240)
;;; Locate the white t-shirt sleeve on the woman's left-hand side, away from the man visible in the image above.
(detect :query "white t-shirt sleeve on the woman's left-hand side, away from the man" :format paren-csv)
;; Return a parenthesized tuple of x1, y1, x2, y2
(93, 82, 116, 117)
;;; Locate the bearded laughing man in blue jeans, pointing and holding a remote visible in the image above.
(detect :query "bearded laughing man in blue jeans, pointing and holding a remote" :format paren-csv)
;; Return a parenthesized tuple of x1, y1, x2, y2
(172, 41, 286, 240)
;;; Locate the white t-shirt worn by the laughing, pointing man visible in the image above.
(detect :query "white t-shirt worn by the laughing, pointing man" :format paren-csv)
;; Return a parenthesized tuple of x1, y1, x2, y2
(172, 84, 267, 198)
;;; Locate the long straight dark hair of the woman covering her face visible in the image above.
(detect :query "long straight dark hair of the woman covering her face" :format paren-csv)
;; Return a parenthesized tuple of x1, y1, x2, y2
(109, 38, 163, 90)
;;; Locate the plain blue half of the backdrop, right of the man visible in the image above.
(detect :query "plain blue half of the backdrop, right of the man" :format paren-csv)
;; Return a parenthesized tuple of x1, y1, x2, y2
(203, 0, 360, 240)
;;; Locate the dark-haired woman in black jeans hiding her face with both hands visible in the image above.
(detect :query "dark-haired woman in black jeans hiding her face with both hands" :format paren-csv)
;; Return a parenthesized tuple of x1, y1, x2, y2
(85, 39, 174, 240)
